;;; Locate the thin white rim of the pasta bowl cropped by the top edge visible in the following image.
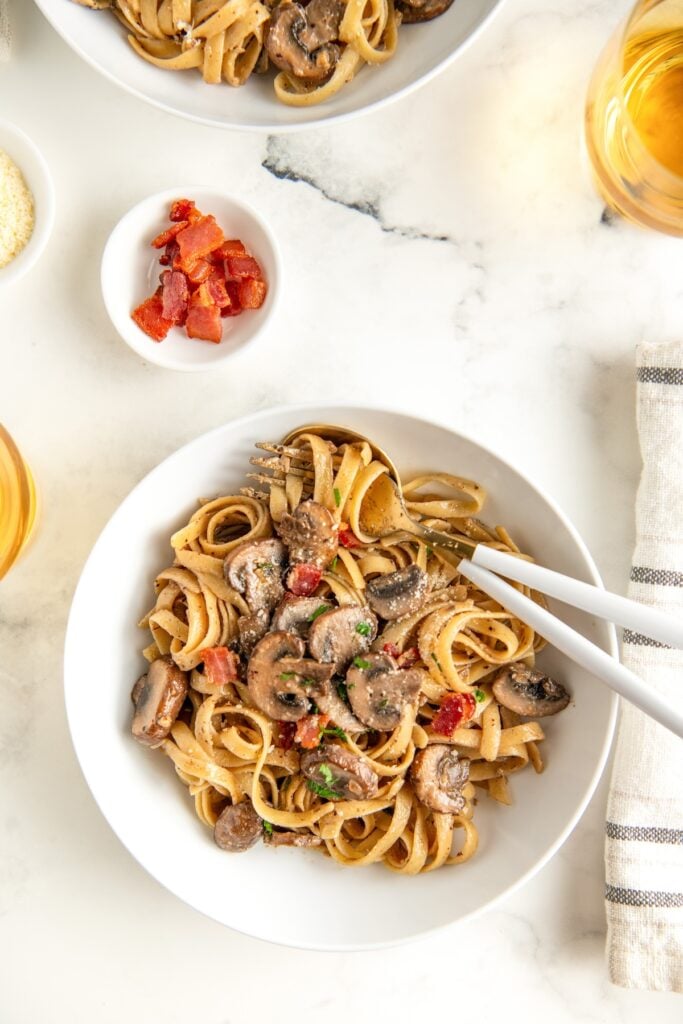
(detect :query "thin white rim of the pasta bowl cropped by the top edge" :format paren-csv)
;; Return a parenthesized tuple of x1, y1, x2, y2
(35, 0, 506, 135)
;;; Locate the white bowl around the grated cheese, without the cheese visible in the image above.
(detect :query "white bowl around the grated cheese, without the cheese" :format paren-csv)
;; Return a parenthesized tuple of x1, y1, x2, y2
(0, 120, 54, 292)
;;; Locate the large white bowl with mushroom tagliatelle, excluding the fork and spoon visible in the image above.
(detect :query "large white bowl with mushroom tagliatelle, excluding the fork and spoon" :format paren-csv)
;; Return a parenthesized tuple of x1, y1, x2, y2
(65, 407, 616, 949)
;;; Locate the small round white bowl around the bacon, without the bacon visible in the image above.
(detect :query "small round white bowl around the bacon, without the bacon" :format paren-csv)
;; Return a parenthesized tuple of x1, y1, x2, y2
(100, 185, 282, 372)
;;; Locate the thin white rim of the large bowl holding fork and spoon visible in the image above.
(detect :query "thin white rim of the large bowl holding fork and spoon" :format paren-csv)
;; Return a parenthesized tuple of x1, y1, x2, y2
(63, 401, 620, 952)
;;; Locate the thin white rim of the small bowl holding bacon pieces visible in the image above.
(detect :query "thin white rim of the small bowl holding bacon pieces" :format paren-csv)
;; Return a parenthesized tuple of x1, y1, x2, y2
(99, 184, 284, 373)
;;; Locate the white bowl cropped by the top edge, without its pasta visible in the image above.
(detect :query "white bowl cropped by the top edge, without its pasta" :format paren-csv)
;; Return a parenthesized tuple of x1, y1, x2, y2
(36, 0, 502, 132)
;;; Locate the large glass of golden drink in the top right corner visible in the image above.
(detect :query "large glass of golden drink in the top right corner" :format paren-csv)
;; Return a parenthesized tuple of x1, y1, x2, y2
(586, 0, 683, 237)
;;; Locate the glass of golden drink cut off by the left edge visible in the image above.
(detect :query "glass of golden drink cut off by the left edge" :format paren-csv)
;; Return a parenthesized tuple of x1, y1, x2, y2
(0, 423, 37, 580)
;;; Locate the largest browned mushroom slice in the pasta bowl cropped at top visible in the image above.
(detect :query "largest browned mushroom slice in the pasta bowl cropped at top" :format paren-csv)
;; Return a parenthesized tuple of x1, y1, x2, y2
(265, 0, 345, 82)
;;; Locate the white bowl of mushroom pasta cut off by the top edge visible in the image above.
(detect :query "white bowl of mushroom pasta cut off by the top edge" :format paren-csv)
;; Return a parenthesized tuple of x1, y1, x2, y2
(36, 0, 501, 132)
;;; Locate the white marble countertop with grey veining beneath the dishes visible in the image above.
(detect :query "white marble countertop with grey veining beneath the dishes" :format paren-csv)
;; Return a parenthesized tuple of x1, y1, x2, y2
(0, 0, 683, 1024)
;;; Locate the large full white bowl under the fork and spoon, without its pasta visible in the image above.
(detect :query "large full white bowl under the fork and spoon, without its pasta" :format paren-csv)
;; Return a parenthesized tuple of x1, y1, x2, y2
(65, 406, 616, 950)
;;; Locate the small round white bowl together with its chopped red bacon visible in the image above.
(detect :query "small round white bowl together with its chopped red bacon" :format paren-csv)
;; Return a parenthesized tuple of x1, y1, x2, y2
(101, 186, 281, 371)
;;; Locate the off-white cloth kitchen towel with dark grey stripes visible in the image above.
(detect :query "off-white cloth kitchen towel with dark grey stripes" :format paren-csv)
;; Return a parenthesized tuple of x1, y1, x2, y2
(605, 342, 683, 992)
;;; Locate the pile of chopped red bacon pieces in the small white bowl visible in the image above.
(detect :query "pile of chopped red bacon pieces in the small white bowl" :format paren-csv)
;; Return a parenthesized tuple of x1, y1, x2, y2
(131, 199, 266, 346)
